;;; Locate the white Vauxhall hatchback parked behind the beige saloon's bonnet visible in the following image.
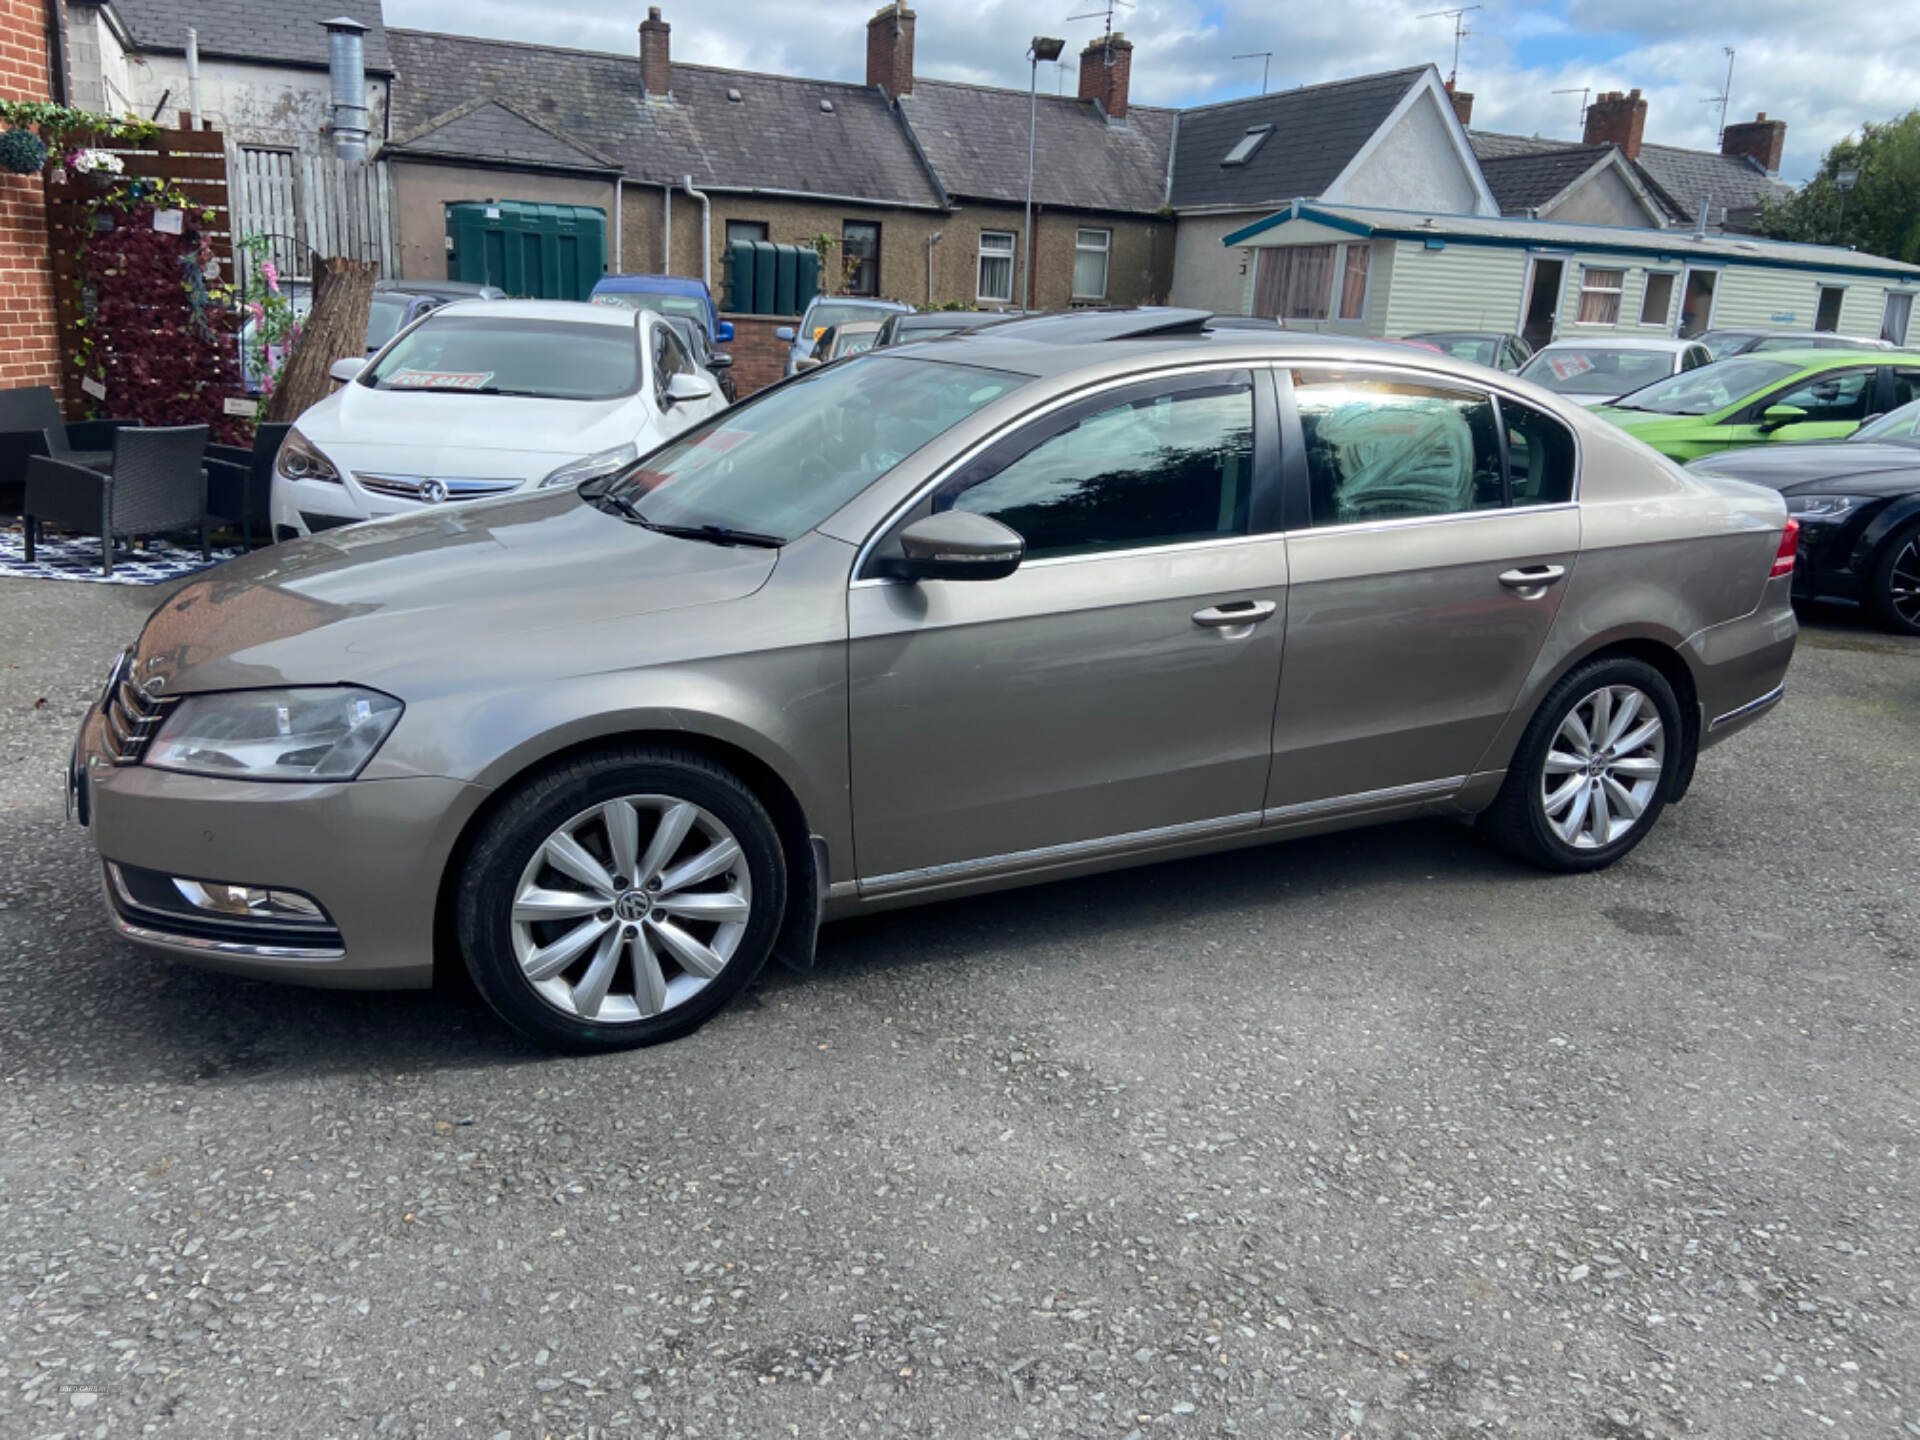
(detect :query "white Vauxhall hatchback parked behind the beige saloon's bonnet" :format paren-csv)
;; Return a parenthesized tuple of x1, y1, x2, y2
(273, 300, 726, 540)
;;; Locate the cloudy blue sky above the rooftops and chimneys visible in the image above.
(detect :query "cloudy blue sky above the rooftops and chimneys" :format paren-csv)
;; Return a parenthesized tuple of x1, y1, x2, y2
(384, 0, 1920, 180)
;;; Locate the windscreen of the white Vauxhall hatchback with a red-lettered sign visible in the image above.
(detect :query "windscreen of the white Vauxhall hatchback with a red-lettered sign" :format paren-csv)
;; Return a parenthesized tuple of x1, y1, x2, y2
(359, 315, 639, 399)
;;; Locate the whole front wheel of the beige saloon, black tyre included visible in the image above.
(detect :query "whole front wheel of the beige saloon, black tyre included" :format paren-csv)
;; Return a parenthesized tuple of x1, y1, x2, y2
(455, 749, 787, 1050)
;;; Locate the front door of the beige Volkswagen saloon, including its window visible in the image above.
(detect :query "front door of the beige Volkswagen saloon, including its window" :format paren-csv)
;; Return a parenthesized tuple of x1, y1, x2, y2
(849, 371, 1286, 895)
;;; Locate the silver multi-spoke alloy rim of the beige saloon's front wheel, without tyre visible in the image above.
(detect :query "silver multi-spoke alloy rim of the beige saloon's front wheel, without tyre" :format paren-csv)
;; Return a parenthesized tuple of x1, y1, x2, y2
(511, 795, 753, 1025)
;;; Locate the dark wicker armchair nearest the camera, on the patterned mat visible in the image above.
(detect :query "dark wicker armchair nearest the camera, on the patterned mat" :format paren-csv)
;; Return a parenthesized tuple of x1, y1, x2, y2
(25, 424, 213, 576)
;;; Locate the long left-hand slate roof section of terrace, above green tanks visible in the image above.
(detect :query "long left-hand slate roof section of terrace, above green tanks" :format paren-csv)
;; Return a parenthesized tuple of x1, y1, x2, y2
(388, 29, 941, 207)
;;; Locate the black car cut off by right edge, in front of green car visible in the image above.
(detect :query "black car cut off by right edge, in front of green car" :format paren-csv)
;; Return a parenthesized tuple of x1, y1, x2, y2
(1688, 399, 1920, 636)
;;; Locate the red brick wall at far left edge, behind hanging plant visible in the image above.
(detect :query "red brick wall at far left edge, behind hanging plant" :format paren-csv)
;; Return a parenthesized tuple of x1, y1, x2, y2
(0, 0, 60, 390)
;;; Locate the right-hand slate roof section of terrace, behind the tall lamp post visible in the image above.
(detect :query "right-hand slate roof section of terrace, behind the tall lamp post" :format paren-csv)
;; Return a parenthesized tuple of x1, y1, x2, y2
(900, 75, 1175, 213)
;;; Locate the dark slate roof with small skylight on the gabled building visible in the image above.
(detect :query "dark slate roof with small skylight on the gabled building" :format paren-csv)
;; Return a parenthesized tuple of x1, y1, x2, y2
(1159, 65, 1432, 209)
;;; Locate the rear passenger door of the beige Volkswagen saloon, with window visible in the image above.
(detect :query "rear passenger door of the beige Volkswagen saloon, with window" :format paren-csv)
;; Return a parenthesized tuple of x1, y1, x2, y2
(1267, 369, 1580, 820)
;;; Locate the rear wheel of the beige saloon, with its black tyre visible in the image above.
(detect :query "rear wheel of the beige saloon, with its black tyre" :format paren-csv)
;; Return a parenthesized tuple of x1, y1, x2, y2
(1480, 657, 1686, 872)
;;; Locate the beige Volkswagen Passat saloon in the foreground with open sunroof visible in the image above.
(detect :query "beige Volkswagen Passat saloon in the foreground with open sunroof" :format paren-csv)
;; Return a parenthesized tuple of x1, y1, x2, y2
(71, 311, 1795, 1048)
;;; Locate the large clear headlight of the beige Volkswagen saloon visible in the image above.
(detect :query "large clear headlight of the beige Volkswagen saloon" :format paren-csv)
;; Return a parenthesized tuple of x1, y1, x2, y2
(146, 685, 405, 780)
